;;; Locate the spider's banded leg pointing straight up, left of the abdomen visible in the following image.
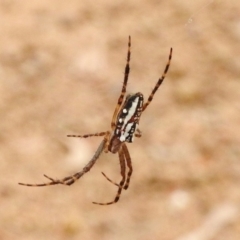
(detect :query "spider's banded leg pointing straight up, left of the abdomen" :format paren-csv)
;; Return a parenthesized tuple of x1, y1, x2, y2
(111, 36, 131, 129)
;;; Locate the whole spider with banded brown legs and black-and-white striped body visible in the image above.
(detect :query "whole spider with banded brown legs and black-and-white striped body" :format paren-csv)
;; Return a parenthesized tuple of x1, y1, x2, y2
(19, 36, 172, 205)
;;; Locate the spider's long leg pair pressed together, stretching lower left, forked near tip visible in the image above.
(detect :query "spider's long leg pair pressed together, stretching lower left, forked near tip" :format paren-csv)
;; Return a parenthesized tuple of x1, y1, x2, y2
(18, 139, 106, 187)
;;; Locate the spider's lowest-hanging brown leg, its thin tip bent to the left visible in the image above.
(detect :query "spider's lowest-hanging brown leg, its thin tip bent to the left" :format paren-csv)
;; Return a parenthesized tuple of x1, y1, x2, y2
(93, 148, 126, 205)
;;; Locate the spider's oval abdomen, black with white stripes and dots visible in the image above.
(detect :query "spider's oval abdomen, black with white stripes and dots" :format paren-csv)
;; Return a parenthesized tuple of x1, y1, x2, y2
(114, 93, 144, 142)
